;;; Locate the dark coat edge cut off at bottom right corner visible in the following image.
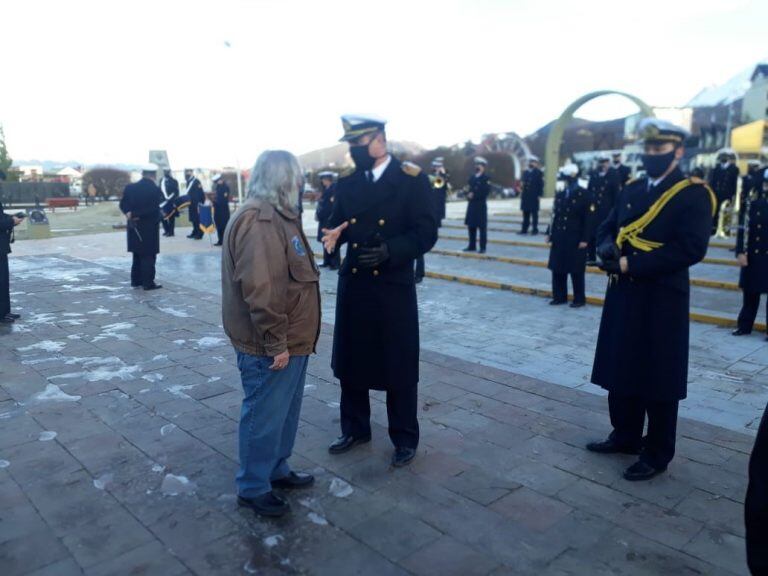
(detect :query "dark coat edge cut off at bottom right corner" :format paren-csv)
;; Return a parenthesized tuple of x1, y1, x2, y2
(744, 406, 768, 576)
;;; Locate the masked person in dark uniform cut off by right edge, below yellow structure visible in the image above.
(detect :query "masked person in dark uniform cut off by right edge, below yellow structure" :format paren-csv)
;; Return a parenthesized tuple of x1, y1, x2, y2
(733, 165, 768, 336)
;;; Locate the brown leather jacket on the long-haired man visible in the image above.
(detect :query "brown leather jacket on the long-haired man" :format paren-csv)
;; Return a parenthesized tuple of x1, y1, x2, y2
(221, 200, 320, 357)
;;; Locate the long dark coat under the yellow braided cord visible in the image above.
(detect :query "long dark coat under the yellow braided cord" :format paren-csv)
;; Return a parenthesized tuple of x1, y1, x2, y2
(592, 168, 713, 401)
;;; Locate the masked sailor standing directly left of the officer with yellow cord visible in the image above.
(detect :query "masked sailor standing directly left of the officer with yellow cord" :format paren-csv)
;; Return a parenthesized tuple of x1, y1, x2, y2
(546, 164, 592, 308)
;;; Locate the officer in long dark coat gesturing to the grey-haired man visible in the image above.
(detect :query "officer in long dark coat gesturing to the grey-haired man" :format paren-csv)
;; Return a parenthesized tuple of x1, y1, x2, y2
(323, 116, 437, 467)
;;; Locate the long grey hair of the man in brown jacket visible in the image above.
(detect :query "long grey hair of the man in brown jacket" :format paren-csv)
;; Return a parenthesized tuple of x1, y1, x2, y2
(248, 150, 304, 212)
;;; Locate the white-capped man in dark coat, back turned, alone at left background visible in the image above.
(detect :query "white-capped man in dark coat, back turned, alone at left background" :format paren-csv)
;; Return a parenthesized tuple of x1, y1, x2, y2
(120, 166, 165, 290)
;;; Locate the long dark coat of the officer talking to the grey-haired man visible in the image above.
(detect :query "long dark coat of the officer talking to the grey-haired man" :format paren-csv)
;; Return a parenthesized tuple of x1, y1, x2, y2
(328, 158, 437, 390)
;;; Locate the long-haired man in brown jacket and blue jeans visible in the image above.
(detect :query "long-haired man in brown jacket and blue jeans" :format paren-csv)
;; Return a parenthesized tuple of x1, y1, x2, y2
(221, 150, 320, 516)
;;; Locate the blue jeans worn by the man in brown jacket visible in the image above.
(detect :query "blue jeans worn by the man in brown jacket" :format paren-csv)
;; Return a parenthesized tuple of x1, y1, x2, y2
(236, 352, 309, 498)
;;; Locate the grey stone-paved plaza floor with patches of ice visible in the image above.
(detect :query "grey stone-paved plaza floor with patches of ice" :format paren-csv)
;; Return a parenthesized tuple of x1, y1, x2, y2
(0, 215, 766, 575)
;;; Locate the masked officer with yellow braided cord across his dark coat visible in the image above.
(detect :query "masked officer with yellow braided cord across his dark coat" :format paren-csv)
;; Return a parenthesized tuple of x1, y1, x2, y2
(587, 118, 717, 481)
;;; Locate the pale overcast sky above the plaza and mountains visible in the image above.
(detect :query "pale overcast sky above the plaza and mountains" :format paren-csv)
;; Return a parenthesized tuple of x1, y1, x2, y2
(0, 0, 768, 169)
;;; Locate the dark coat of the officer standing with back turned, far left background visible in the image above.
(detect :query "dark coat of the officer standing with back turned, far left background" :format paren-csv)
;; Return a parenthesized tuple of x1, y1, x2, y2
(120, 178, 165, 256)
